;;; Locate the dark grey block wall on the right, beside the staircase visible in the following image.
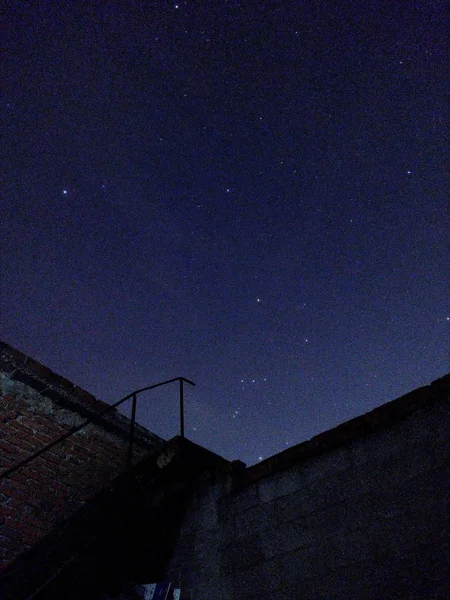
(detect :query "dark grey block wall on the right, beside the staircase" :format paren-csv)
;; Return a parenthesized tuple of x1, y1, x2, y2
(168, 376, 450, 600)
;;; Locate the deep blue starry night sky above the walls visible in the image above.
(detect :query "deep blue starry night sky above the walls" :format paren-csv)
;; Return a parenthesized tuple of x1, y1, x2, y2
(1, 0, 450, 464)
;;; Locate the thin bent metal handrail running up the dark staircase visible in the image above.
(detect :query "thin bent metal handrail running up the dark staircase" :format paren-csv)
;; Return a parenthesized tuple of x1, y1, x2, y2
(0, 377, 195, 480)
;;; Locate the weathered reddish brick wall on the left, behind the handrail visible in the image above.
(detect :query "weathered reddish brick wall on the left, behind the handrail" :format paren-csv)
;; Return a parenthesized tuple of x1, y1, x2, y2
(0, 343, 163, 568)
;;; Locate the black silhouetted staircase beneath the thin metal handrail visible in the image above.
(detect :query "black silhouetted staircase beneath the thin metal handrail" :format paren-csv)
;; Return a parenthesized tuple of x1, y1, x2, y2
(0, 436, 229, 600)
